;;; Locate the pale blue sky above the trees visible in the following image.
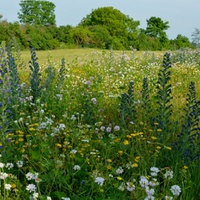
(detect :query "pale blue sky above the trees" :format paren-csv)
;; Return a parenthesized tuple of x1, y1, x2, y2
(0, 0, 200, 40)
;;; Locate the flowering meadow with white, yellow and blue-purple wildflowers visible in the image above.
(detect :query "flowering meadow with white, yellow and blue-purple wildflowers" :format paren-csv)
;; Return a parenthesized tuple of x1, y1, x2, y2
(0, 45, 200, 200)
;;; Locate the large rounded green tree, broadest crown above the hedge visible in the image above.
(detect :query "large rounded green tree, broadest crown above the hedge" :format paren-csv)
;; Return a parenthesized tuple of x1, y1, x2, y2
(79, 7, 140, 48)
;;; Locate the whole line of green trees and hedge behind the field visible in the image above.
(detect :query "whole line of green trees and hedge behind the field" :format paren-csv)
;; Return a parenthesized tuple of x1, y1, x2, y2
(0, 0, 198, 50)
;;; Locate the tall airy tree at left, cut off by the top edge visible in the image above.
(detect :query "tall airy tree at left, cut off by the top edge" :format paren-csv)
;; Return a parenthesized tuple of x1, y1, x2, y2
(18, 0, 56, 26)
